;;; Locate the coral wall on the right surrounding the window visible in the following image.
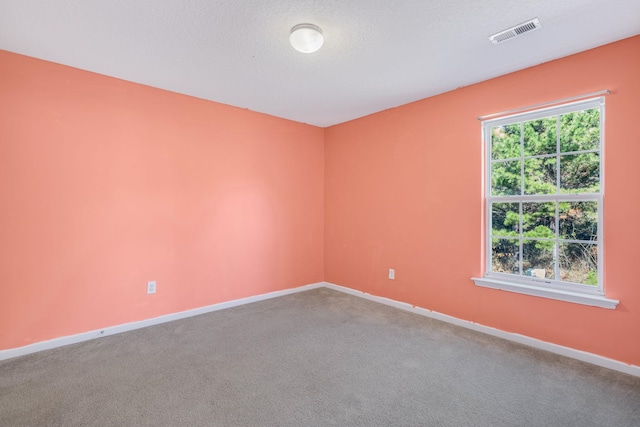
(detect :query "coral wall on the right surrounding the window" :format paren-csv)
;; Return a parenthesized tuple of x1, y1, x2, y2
(325, 36, 640, 365)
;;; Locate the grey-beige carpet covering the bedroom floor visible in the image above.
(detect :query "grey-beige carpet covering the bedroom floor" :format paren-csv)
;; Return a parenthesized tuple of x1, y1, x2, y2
(0, 288, 640, 427)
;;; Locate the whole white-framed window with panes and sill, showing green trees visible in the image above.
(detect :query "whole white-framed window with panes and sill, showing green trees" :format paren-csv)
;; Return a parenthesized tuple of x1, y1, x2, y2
(474, 98, 617, 308)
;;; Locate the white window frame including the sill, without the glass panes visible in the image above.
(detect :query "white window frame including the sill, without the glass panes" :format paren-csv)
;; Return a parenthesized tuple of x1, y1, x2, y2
(473, 97, 619, 309)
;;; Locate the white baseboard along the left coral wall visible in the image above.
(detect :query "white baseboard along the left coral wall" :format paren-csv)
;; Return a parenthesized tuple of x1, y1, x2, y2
(0, 282, 324, 360)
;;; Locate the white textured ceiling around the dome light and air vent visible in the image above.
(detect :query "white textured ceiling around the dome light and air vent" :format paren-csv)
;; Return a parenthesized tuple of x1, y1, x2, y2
(0, 0, 640, 127)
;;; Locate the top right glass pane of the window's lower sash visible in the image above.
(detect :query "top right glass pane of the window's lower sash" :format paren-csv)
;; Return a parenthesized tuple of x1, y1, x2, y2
(559, 202, 598, 241)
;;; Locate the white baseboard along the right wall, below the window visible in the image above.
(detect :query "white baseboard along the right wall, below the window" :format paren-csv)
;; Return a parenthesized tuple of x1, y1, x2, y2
(324, 282, 640, 377)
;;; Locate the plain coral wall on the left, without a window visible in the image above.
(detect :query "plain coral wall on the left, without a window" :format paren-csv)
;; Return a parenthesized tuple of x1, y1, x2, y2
(0, 51, 324, 349)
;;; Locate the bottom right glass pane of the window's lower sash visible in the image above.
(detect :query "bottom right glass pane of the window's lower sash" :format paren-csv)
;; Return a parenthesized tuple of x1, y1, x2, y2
(559, 243, 598, 285)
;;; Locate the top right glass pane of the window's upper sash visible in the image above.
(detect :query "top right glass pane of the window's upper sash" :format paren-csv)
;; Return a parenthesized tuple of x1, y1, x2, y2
(560, 108, 600, 153)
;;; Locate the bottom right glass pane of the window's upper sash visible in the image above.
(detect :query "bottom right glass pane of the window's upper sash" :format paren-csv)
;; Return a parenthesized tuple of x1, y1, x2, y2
(560, 153, 600, 193)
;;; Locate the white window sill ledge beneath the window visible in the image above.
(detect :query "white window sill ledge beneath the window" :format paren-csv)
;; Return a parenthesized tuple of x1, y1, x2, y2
(471, 277, 620, 310)
